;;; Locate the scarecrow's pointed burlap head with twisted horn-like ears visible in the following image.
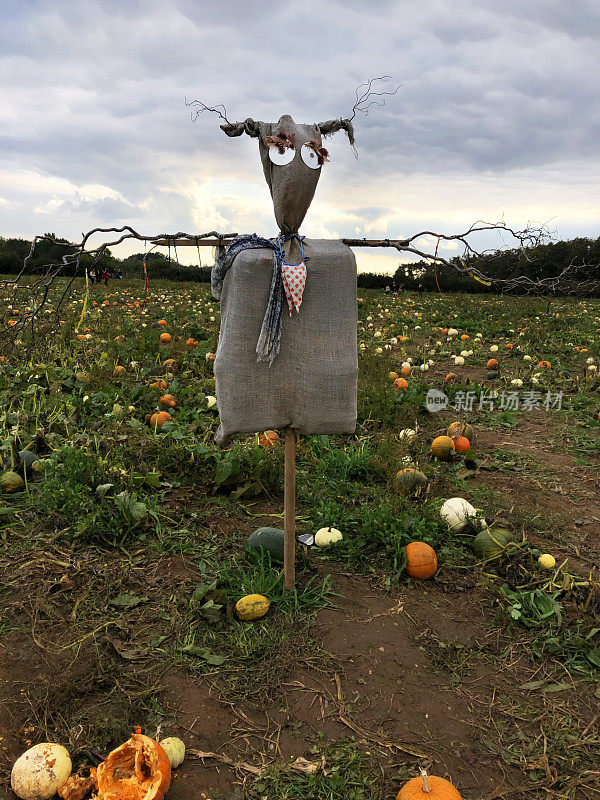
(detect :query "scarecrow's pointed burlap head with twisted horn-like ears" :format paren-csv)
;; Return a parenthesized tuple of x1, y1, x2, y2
(221, 114, 354, 233)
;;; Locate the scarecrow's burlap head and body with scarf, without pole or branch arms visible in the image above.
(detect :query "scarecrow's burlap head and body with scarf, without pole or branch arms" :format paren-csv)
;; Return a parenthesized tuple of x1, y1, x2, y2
(206, 106, 366, 445)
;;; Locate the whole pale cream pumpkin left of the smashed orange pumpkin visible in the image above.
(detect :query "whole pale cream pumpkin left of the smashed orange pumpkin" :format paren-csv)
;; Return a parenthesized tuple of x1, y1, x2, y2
(10, 742, 72, 800)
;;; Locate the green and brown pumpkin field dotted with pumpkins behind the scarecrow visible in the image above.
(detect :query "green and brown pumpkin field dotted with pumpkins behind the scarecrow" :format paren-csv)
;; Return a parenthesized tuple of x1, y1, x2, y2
(0, 276, 600, 800)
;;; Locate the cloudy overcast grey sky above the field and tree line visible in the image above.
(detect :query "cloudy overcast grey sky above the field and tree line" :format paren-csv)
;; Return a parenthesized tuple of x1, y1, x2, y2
(0, 0, 600, 271)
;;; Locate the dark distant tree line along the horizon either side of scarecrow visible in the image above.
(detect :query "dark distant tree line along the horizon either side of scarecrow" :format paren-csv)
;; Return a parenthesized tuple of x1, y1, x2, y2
(0, 234, 600, 296)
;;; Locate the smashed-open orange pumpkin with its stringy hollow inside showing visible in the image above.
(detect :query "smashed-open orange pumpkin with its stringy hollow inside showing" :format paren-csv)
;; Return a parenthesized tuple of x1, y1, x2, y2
(95, 728, 171, 800)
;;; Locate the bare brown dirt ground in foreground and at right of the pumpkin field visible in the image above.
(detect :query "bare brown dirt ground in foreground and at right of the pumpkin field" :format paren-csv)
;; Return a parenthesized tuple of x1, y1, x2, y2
(0, 414, 600, 800)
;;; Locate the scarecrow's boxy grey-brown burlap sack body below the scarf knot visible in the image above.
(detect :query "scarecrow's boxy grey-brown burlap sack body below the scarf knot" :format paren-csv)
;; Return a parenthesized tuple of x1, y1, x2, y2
(214, 239, 358, 445)
